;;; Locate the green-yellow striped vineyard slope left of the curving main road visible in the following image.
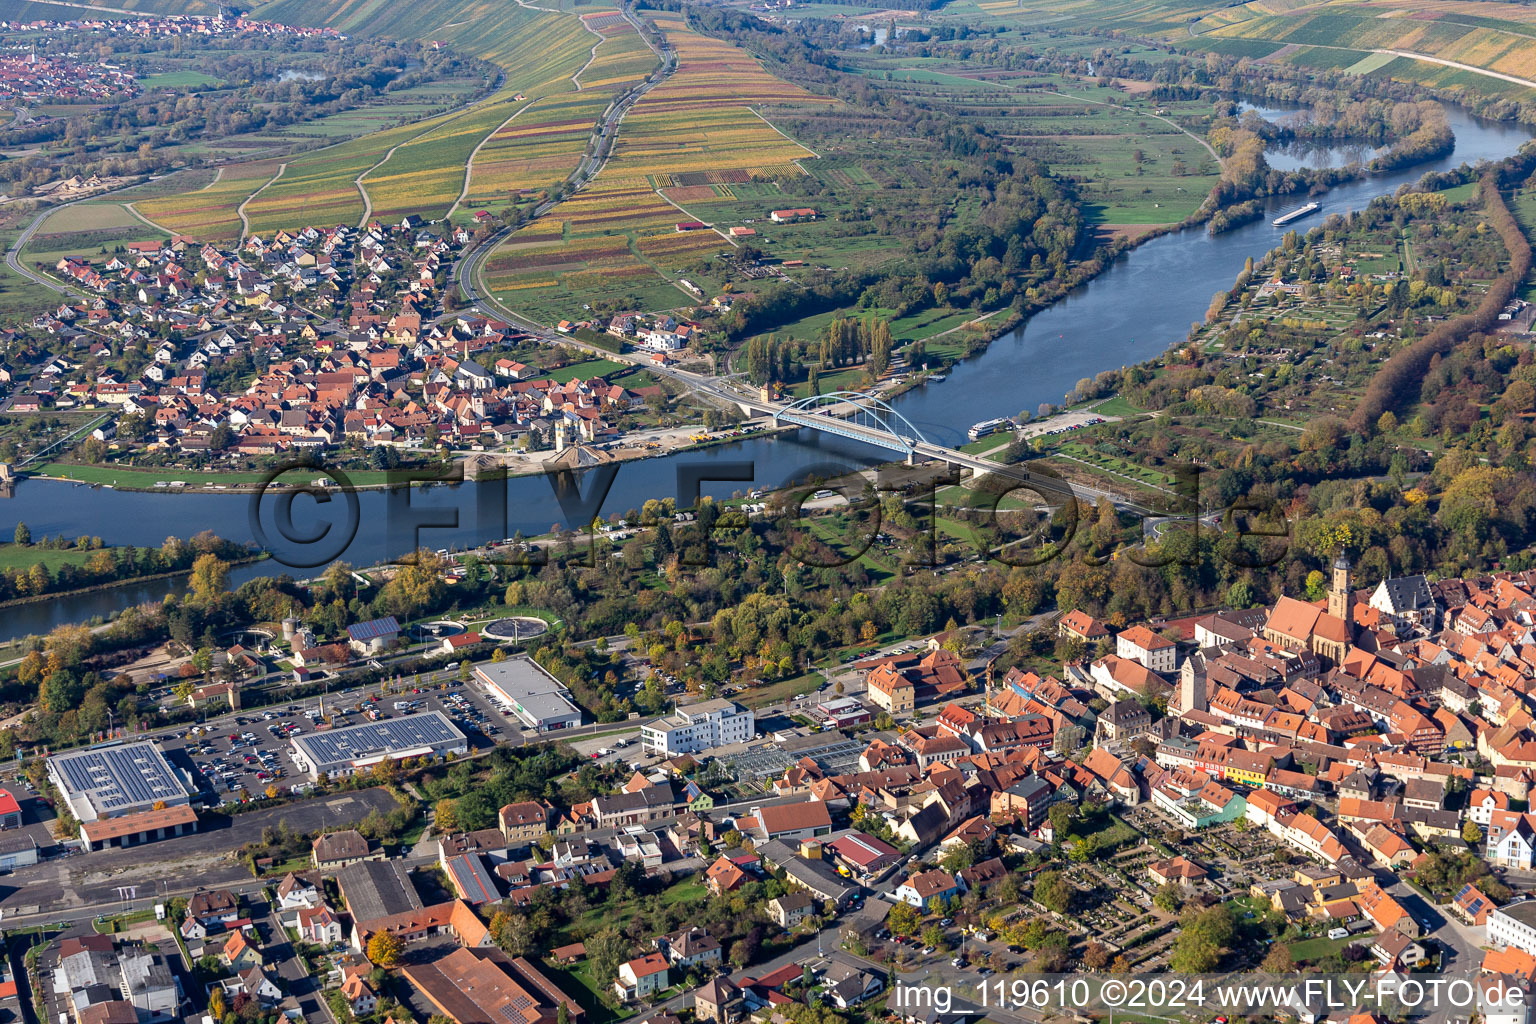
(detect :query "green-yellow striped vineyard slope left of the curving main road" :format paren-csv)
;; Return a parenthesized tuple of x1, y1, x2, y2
(130, 0, 635, 239)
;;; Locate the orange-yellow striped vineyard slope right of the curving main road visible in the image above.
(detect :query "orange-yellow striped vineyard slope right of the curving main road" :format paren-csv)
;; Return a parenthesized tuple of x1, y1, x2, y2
(476, 12, 826, 322)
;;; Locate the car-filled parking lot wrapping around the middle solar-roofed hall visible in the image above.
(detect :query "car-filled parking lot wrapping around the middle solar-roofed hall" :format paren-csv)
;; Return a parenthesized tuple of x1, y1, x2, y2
(140, 671, 522, 803)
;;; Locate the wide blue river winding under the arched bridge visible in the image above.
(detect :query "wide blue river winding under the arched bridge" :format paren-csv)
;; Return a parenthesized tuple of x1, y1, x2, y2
(0, 107, 1531, 637)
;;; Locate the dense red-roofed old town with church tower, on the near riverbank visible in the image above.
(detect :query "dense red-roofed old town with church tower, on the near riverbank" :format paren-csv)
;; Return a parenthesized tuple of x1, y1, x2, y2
(21, 564, 1536, 1024)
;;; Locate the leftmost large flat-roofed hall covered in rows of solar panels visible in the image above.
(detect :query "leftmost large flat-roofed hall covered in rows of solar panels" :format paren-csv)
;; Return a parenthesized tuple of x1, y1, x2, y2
(48, 740, 192, 821)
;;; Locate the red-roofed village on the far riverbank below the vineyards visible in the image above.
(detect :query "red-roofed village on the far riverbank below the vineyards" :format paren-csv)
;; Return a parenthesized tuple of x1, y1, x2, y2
(18, 221, 660, 465)
